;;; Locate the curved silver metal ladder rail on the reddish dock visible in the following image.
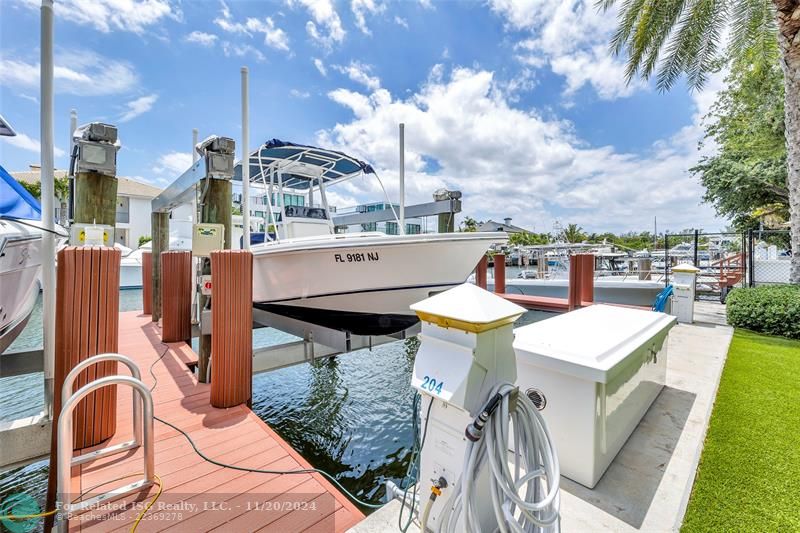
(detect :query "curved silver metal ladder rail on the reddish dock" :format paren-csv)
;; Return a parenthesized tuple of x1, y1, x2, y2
(56, 353, 155, 530)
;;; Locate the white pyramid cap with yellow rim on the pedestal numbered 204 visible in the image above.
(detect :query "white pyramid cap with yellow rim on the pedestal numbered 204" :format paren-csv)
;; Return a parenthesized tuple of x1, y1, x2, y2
(411, 283, 525, 333)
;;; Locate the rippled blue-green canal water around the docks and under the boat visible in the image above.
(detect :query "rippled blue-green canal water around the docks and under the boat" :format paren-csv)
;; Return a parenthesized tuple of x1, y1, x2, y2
(0, 274, 552, 512)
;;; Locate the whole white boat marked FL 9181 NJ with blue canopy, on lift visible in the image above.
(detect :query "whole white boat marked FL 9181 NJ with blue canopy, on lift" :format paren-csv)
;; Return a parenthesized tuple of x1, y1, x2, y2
(234, 139, 508, 335)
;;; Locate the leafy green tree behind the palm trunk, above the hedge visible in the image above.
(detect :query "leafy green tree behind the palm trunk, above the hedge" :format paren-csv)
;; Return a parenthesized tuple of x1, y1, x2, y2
(689, 50, 789, 231)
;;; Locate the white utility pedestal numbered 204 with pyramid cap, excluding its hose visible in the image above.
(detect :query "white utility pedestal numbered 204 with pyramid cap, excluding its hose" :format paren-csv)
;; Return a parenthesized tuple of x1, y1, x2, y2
(411, 284, 525, 531)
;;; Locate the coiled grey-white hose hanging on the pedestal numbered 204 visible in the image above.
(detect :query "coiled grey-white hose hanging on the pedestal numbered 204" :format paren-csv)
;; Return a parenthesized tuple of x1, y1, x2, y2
(440, 383, 561, 533)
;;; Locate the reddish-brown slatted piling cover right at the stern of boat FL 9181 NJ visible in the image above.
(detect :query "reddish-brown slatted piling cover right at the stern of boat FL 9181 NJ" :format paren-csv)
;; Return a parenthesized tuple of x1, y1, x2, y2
(211, 250, 253, 407)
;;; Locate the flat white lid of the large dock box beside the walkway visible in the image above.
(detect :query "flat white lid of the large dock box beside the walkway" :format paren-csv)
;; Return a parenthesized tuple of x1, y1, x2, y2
(514, 305, 675, 383)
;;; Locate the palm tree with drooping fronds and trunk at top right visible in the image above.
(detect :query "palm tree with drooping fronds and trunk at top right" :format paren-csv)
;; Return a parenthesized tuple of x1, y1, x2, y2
(598, 0, 800, 283)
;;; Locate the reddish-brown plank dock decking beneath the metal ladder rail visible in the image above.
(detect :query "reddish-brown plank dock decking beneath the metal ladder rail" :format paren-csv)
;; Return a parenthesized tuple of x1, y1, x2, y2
(70, 311, 364, 533)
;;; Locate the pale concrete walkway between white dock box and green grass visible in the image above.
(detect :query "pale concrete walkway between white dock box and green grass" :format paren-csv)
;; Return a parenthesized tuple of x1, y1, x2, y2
(350, 302, 733, 533)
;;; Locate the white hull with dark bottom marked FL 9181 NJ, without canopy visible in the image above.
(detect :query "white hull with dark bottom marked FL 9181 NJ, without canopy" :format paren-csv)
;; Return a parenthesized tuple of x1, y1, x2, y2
(253, 233, 505, 335)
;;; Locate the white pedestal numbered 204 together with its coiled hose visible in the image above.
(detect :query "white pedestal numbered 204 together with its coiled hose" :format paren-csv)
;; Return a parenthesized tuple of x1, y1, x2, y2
(411, 283, 559, 532)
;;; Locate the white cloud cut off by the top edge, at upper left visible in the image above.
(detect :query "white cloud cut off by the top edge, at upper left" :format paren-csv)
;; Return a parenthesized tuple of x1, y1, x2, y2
(17, 0, 183, 34)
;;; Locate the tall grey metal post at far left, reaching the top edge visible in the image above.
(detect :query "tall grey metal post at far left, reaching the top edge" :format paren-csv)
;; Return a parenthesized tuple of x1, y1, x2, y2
(39, 0, 56, 419)
